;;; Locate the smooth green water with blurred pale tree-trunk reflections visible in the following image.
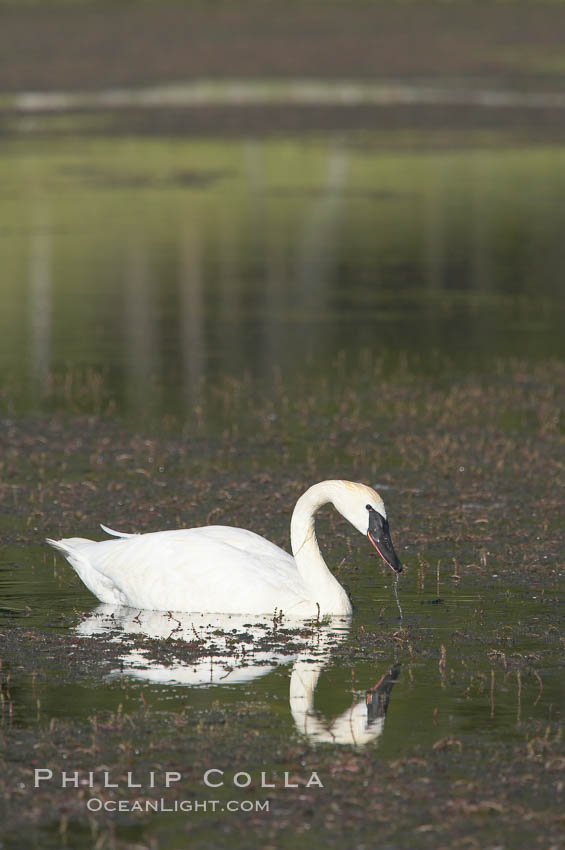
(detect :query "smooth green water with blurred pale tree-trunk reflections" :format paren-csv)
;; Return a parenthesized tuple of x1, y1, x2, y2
(0, 137, 565, 413)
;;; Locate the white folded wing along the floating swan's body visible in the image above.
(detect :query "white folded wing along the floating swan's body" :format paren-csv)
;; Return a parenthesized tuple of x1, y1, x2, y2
(70, 526, 306, 613)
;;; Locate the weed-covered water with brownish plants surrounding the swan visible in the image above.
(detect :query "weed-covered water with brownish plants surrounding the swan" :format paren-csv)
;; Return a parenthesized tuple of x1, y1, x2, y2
(0, 354, 564, 850)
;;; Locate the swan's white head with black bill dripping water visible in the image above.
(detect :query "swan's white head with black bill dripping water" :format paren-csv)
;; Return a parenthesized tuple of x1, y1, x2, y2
(334, 481, 402, 573)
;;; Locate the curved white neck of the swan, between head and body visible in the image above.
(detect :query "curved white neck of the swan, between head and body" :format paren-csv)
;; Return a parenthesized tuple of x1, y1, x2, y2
(290, 481, 352, 615)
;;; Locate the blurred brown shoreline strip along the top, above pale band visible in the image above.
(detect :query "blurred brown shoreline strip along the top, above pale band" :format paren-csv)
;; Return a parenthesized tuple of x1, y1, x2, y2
(0, 0, 565, 92)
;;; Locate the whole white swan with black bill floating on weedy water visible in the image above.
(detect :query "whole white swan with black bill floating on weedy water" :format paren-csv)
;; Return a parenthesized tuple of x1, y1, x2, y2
(47, 481, 402, 617)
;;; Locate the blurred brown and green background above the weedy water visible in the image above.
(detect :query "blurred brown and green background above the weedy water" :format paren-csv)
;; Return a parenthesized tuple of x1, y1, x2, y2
(0, 2, 565, 412)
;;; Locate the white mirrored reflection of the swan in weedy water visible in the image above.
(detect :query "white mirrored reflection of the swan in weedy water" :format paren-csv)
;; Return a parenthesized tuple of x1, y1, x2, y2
(77, 605, 400, 746)
